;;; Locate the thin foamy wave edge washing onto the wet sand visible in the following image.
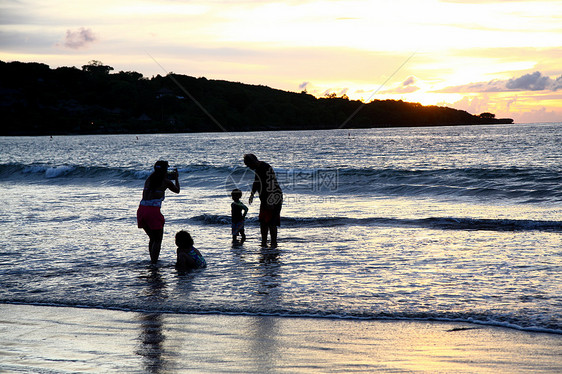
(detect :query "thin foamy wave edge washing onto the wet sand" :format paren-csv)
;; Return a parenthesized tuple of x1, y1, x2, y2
(0, 299, 562, 335)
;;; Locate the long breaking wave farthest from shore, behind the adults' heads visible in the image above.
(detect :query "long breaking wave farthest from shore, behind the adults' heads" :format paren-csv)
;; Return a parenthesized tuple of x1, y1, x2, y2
(0, 163, 562, 203)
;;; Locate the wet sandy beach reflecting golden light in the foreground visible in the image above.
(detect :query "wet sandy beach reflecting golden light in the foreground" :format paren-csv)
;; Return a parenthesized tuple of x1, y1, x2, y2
(0, 304, 562, 373)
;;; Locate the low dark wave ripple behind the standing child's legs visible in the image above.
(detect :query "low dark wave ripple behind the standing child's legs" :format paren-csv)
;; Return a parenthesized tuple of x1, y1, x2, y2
(185, 214, 562, 232)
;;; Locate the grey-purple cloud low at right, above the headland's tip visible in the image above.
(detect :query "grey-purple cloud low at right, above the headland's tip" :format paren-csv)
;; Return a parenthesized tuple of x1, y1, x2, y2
(435, 71, 562, 93)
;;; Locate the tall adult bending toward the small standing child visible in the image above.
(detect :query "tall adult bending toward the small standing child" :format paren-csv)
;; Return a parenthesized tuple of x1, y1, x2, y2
(244, 153, 283, 248)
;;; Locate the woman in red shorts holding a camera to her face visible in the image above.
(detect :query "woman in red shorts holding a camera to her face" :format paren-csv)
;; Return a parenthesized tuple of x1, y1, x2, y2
(137, 161, 180, 264)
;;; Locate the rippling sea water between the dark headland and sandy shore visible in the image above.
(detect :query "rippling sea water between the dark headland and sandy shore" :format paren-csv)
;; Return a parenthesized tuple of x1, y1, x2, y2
(0, 124, 562, 333)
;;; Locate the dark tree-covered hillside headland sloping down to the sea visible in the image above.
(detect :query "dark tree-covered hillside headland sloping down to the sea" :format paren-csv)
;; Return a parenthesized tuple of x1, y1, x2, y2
(0, 61, 513, 135)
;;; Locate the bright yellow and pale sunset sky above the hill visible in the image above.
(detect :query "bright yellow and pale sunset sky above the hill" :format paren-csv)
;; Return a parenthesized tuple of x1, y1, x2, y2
(0, 0, 562, 123)
